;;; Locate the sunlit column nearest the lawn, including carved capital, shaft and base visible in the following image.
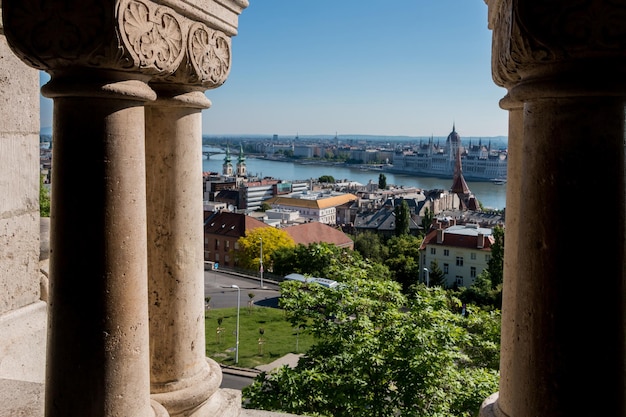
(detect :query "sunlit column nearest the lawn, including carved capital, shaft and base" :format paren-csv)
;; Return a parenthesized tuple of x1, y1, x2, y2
(141, 2, 246, 417)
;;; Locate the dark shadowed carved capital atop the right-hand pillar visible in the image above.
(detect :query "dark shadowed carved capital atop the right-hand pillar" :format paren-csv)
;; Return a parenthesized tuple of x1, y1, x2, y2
(485, 0, 626, 94)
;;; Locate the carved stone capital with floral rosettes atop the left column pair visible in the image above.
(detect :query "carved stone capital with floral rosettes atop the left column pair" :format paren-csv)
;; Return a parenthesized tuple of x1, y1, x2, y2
(2, 0, 247, 88)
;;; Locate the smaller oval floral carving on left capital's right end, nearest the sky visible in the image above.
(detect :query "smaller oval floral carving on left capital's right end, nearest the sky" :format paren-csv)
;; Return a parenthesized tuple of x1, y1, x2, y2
(188, 23, 231, 87)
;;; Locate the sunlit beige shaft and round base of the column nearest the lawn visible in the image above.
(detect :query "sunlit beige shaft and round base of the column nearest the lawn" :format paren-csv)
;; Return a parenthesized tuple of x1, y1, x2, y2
(146, 90, 227, 416)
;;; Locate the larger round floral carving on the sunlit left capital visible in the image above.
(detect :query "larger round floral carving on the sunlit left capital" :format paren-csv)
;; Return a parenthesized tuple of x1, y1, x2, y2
(119, 0, 185, 74)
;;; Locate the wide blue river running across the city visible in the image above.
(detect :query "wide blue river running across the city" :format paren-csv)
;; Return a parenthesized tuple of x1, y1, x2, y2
(203, 154, 506, 210)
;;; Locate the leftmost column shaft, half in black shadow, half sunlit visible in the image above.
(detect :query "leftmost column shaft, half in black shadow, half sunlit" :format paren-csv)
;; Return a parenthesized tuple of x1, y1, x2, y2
(43, 77, 163, 417)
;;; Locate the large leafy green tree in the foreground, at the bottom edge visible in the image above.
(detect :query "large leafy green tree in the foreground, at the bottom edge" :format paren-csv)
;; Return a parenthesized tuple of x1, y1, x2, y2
(243, 280, 500, 417)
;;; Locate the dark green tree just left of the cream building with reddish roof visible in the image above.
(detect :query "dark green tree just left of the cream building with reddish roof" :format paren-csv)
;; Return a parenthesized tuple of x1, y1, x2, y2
(385, 235, 422, 291)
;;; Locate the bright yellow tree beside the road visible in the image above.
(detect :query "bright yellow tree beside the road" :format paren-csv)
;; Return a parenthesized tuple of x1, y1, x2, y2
(235, 227, 295, 271)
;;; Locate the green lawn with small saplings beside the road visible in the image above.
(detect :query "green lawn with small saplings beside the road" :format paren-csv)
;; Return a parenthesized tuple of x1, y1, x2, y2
(205, 306, 314, 368)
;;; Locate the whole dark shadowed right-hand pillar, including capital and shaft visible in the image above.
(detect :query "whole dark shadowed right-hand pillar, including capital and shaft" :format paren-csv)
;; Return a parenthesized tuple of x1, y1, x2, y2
(481, 0, 626, 417)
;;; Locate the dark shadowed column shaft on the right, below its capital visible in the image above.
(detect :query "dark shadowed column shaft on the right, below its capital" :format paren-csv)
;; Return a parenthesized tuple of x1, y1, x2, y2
(505, 97, 625, 416)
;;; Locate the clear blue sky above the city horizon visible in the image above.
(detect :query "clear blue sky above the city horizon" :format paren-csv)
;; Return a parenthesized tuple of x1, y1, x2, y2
(42, 0, 508, 137)
